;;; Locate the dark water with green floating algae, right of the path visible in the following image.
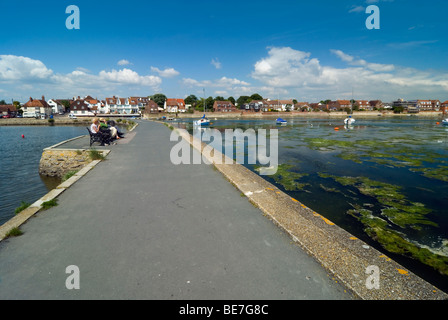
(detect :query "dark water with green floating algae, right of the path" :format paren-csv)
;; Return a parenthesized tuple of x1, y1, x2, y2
(176, 116, 448, 290)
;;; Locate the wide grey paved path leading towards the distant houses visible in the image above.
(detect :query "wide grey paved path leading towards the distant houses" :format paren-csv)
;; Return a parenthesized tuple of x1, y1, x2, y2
(0, 121, 352, 300)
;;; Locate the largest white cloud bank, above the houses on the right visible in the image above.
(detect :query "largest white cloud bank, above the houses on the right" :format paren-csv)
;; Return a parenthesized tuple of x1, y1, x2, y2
(252, 47, 448, 101)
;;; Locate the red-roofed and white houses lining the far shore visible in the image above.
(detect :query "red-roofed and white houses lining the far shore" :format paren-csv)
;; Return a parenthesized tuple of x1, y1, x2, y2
(0, 96, 448, 117)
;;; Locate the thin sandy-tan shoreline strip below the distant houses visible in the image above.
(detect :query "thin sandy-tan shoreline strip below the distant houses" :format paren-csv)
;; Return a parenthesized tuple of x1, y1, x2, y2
(0, 111, 448, 126)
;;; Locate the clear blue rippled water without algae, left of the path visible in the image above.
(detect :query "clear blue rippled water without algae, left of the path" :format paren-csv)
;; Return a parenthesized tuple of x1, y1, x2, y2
(0, 126, 86, 225)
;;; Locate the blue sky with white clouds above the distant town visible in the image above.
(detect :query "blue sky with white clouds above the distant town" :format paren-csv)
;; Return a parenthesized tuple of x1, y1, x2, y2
(0, 0, 448, 102)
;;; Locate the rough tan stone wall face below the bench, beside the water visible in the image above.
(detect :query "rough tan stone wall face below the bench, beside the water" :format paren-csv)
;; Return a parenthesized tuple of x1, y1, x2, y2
(39, 149, 92, 178)
